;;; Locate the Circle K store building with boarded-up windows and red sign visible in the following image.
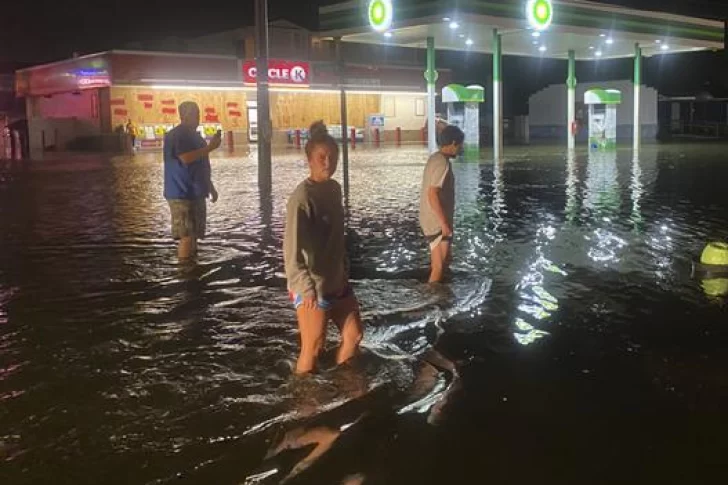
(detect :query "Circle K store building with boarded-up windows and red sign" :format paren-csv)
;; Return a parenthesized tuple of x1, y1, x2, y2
(17, 21, 451, 151)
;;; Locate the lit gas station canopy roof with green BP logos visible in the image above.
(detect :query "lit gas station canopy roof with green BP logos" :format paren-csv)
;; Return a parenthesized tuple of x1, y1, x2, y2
(319, 0, 724, 60)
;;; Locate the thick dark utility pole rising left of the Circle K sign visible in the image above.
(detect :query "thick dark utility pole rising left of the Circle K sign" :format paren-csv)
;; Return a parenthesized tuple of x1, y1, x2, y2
(255, 0, 273, 193)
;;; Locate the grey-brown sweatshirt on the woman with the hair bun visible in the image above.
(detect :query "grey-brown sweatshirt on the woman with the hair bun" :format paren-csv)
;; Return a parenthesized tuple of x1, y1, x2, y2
(283, 179, 349, 299)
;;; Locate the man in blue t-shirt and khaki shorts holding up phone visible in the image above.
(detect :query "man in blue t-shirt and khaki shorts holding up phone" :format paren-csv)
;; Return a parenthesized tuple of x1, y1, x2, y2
(164, 101, 221, 261)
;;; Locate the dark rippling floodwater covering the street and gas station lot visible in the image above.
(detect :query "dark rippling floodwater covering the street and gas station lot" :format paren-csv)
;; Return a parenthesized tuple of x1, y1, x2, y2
(0, 145, 728, 485)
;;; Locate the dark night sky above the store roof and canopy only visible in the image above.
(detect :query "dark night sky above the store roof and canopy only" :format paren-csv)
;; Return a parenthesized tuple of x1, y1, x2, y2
(0, 0, 728, 62)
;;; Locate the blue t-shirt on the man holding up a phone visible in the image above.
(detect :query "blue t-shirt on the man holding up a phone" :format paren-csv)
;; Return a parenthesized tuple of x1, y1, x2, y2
(164, 125, 210, 199)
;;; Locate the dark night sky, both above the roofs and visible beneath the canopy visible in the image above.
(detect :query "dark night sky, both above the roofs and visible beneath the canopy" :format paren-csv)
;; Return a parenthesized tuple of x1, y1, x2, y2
(0, 0, 728, 104)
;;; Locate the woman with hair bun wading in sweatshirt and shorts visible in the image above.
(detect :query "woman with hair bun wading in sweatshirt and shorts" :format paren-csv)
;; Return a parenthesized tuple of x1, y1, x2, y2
(283, 122, 362, 374)
